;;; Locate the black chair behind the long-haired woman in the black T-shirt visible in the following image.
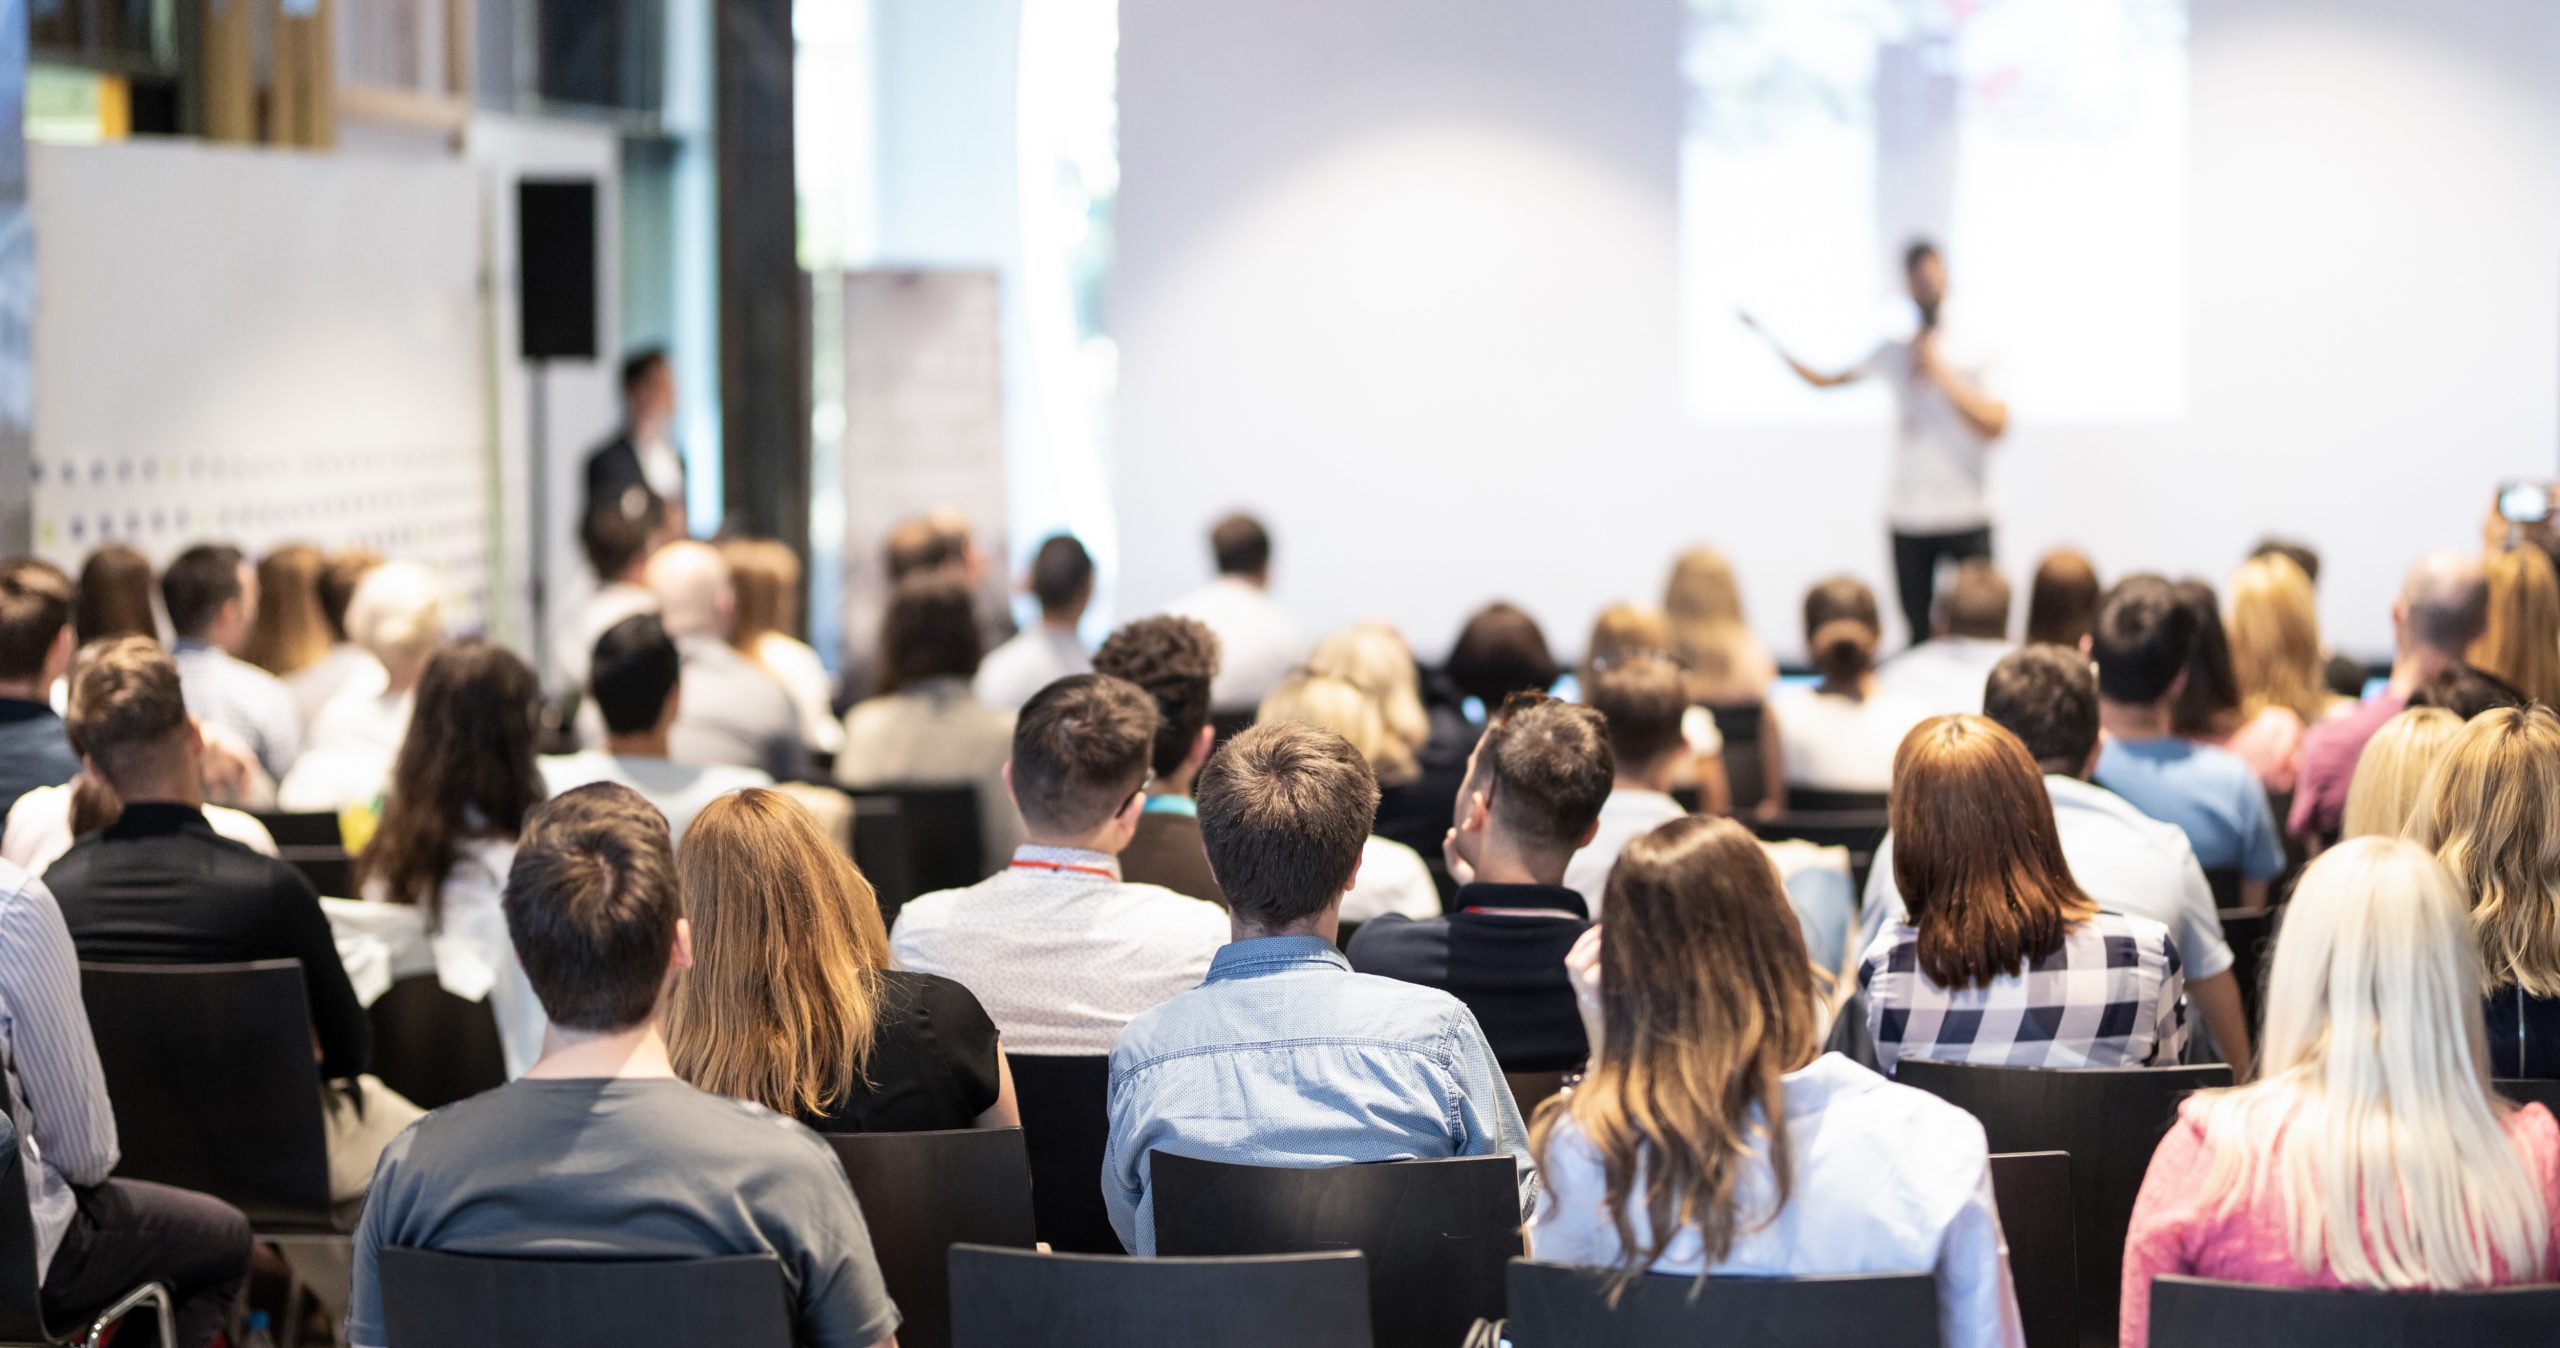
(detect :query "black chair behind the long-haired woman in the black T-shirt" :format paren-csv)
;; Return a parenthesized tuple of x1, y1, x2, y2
(827, 1128, 1032, 1348)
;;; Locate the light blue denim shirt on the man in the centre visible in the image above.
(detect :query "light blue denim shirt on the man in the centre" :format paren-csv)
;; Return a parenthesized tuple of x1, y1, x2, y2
(1101, 936, 1539, 1256)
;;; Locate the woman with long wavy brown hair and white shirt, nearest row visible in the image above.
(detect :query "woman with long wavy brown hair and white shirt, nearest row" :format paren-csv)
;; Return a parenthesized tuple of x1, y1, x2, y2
(1528, 816, 2022, 1348)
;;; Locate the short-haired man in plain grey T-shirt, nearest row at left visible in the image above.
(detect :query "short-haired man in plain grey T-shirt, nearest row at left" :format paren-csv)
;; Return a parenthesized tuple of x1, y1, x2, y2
(346, 783, 899, 1348)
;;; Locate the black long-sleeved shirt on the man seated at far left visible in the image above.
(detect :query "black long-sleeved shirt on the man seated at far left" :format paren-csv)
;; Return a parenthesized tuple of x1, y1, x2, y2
(44, 803, 371, 1077)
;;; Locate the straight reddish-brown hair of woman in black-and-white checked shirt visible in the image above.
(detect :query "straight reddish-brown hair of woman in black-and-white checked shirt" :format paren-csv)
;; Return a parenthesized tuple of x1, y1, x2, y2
(1892, 716, 2097, 987)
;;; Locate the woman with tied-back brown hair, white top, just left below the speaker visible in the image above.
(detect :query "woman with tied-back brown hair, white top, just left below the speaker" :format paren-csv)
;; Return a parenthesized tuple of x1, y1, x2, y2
(1769, 576, 1928, 795)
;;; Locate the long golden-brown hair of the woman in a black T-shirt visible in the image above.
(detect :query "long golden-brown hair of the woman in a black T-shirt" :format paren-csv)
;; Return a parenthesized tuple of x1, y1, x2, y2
(666, 788, 888, 1118)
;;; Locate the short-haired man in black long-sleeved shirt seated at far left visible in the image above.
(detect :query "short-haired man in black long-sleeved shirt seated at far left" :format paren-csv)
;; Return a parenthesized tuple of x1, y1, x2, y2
(46, 637, 417, 1200)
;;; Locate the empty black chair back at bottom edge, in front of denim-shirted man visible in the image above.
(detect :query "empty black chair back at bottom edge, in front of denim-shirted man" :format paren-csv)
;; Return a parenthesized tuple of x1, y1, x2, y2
(952, 1246, 1372, 1348)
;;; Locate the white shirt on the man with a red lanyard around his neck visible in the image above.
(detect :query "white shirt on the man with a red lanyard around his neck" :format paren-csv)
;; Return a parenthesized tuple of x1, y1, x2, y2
(888, 844, 1229, 1056)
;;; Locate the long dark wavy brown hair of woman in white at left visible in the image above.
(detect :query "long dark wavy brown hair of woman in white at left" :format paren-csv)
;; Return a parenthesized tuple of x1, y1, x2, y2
(356, 639, 543, 931)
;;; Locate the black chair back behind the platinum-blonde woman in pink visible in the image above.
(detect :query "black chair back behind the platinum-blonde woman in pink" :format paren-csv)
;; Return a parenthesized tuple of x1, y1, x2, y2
(2150, 1276, 2560, 1348)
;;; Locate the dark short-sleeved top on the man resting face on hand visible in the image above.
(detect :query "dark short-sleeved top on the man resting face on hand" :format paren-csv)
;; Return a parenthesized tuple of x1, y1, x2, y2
(1347, 885, 1590, 1072)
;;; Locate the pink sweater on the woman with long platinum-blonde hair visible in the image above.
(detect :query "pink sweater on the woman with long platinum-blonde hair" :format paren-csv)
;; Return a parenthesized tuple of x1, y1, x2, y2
(2117, 1102, 2560, 1348)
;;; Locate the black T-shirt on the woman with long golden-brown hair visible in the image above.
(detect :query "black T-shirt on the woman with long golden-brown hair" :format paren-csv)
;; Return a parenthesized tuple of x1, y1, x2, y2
(801, 969, 1004, 1133)
